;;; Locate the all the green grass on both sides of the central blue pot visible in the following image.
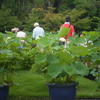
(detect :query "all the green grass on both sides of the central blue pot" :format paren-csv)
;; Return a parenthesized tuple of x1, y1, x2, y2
(9, 71, 100, 100)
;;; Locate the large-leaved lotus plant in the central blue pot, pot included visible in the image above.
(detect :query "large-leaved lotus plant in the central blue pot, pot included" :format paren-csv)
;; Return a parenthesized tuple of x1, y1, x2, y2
(32, 34, 89, 100)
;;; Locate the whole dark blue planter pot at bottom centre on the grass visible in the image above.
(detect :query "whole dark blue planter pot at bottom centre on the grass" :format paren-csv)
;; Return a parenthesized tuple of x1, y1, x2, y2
(46, 83, 78, 100)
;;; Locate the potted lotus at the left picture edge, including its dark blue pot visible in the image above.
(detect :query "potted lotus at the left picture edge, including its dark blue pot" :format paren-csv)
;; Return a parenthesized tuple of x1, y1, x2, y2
(0, 33, 21, 100)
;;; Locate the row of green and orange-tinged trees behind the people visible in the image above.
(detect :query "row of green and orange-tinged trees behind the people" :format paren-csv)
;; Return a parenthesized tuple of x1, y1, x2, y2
(24, 4, 99, 33)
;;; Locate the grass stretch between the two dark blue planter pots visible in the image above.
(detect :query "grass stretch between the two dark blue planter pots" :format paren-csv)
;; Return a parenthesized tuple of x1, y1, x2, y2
(10, 71, 48, 96)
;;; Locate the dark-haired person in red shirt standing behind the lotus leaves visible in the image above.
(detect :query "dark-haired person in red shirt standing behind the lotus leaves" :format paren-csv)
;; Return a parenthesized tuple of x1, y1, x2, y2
(61, 17, 75, 41)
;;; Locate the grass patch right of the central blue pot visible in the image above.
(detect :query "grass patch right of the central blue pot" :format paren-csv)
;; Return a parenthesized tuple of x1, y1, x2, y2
(77, 77, 100, 98)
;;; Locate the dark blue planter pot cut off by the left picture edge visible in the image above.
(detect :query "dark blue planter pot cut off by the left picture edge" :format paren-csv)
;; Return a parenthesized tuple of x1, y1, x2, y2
(0, 86, 9, 100)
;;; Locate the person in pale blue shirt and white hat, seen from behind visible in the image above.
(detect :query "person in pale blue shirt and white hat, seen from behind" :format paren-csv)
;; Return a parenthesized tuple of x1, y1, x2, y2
(32, 23, 45, 39)
